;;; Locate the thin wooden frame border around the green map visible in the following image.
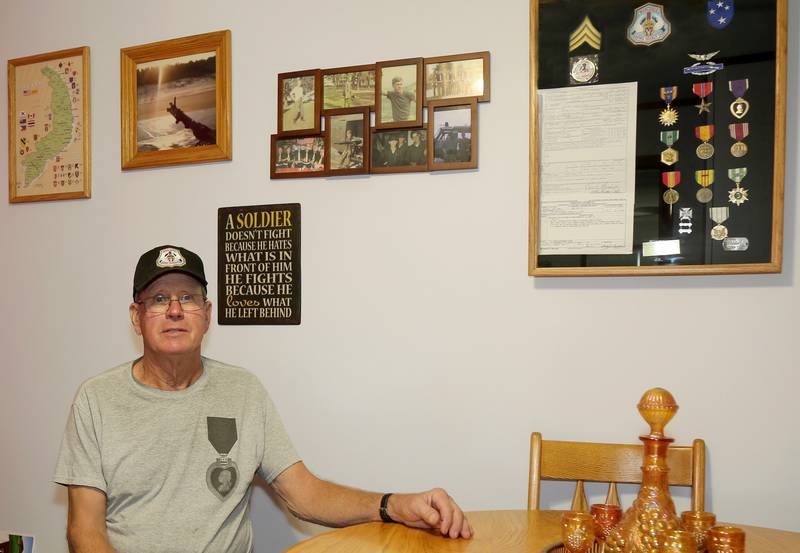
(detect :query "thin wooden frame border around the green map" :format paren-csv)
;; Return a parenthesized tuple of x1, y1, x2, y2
(8, 46, 92, 203)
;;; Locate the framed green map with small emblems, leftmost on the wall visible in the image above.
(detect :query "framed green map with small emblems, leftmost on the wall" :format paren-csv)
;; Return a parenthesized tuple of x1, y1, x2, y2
(8, 46, 92, 203)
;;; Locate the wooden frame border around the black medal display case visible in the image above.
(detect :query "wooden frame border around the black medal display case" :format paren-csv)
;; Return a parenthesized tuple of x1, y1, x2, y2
(528, 0, 788, 277)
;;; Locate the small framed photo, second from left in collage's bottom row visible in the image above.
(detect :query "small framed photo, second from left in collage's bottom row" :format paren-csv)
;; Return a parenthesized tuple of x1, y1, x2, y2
(325, 107, 369, 176)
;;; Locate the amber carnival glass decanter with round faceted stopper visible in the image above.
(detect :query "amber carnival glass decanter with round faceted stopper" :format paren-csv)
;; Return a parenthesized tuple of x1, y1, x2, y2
(605, 388, 679, 553)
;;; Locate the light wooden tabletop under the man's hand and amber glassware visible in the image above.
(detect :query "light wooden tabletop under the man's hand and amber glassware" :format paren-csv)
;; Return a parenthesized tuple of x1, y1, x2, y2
(286, 511, 800, 553)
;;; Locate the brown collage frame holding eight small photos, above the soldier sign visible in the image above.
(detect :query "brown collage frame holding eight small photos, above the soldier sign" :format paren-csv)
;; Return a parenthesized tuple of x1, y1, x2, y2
(270, 52, 490, 179)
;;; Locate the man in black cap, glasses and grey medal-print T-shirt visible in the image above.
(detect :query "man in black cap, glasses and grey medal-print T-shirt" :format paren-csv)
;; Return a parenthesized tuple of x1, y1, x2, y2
(54, 246, 472, 553)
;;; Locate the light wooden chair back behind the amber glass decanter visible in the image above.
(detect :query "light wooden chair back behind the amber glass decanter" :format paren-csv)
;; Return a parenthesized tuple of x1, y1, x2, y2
(528, 432, 706, 512)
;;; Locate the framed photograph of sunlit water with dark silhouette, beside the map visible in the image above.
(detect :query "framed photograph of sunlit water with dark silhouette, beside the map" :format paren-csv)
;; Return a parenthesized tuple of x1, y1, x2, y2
(120, 31, 232, 169)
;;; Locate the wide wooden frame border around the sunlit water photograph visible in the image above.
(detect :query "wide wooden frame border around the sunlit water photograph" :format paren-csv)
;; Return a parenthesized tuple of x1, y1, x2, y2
(120, 30, 233, 169)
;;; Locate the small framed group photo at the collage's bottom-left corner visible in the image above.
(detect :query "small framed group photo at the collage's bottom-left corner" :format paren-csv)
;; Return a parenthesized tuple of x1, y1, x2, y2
(269, 134, 327, 179)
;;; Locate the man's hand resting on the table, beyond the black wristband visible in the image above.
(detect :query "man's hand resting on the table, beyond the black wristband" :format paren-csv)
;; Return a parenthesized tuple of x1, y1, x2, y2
(386, 488, 473, 539)
